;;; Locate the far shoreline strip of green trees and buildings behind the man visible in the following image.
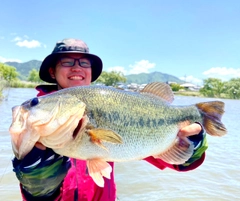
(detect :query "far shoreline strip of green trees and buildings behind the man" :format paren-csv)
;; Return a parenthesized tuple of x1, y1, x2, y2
(0, 63, 240, 100)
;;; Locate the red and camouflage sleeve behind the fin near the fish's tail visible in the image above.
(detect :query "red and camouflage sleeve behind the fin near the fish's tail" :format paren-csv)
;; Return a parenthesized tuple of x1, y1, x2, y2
(144, 127, 208, 171)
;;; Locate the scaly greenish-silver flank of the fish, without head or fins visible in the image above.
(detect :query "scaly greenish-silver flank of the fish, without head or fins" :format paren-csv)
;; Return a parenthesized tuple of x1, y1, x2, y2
(52, 87, 201, 161)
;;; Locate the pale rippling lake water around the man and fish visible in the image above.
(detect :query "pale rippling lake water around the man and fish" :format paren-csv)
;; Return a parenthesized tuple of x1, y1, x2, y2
(0, 89, 240, 201)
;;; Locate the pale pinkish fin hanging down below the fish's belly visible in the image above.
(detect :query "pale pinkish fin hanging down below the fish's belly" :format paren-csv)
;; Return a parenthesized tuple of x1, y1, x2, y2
(87, 159, 112, 187)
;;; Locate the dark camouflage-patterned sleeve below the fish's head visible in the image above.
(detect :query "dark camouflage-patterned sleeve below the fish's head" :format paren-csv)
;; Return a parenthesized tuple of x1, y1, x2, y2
(13, 147, 71, 201)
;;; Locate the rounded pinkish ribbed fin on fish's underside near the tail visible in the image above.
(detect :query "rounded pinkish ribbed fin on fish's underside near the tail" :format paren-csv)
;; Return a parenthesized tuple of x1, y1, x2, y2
(154, 138, 194, 165)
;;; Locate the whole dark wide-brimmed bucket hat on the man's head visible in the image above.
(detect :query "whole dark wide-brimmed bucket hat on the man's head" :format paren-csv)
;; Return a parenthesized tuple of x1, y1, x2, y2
(39, 38, 103, 83)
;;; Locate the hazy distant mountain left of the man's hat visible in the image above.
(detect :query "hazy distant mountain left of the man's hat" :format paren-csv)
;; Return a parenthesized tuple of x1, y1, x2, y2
(5, 60, 42, 80)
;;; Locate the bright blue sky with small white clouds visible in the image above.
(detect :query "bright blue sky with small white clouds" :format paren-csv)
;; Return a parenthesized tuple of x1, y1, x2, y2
(0, 0, 240, 84)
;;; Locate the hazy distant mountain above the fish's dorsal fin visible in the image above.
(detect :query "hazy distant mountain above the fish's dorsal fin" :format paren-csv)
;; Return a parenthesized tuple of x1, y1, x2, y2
(126, 72, 184, 84)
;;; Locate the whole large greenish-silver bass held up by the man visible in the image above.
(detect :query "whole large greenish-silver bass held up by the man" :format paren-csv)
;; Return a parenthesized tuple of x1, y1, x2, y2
(10, 83, 226, 186)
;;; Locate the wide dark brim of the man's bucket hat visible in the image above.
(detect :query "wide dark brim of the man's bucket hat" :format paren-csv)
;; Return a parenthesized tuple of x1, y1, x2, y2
(39, 51, 103, 83)
